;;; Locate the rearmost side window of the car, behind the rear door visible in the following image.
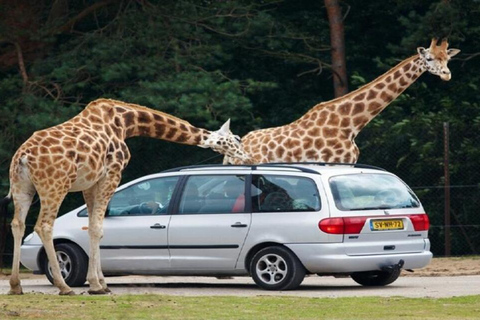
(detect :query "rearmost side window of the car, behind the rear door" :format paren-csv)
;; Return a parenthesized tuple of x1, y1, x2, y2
(251, 175, 321, 212)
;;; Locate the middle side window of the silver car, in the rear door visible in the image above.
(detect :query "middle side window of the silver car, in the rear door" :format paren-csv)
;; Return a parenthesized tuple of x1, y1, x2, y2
(178, 175, 245, 214)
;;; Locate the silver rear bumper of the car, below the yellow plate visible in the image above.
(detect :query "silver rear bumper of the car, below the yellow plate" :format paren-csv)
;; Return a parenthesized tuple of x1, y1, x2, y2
(286, 240, 433, 273)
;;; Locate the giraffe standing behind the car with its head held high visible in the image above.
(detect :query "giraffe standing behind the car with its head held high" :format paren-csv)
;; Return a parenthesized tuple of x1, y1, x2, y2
(224, 39, 460, 164)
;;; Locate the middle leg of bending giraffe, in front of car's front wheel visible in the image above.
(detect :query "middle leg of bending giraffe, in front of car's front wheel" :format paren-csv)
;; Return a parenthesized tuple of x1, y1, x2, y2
(35, 189, 75, 295)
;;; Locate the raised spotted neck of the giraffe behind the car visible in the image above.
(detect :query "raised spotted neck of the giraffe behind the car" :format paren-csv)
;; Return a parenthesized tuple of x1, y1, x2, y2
(295, 55, 426, 138)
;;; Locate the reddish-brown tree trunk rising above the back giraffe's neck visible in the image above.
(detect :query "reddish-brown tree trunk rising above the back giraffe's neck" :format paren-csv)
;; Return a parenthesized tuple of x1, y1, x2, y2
(324, 0, 348, 97)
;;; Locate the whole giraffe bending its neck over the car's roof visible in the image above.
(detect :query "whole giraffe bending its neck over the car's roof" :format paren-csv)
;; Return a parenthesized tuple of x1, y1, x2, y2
(2, 99, 248, 295)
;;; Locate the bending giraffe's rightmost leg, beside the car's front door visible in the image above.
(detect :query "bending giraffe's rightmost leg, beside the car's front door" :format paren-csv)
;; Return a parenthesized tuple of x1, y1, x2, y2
(87, 170, 121, 294)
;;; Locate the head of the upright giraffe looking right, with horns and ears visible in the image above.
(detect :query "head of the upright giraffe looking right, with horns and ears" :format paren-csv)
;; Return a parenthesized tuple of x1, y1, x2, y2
(417, 38, 460, 81)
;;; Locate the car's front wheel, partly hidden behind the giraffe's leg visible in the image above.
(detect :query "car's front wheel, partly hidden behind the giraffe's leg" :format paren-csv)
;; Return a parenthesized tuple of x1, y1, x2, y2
(43, 243, 88, 287)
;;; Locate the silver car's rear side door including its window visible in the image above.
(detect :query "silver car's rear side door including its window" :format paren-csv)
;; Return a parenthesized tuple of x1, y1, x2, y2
(168, 174, 251, 270)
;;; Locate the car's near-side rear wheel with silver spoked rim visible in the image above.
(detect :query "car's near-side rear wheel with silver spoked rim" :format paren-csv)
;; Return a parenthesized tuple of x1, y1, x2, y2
(250, 247, 306, 290)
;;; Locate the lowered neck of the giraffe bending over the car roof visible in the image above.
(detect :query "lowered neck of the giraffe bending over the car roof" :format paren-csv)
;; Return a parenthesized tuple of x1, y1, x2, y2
(85, 99, 210, 145)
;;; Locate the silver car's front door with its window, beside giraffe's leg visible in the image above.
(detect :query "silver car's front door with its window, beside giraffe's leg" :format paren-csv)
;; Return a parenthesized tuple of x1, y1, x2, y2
(100, 176, 178, 273)
